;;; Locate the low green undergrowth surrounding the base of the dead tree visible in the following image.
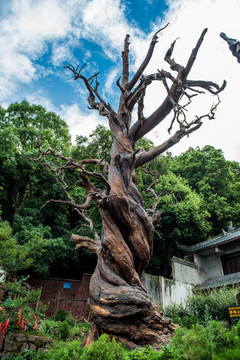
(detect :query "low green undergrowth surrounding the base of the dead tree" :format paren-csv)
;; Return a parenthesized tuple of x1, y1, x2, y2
(0, 281, 240, 360)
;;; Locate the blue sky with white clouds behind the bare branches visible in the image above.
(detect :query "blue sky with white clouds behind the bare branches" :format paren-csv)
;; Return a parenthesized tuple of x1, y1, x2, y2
(0, 0, 240, 161)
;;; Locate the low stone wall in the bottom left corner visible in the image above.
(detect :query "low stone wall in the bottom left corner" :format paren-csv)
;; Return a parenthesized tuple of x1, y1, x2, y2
(0, 332, 53, 358)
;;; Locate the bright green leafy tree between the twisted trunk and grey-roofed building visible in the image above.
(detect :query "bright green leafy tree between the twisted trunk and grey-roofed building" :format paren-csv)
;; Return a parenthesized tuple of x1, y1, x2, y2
(145, 172, 211, 277)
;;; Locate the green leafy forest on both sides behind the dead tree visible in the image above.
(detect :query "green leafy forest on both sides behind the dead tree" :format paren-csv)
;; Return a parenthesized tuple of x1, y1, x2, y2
(0, 101, 240, 279)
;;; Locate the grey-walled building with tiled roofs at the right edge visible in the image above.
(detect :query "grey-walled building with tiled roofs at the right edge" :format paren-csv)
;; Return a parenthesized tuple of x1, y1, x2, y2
(172, 226, 240, 290)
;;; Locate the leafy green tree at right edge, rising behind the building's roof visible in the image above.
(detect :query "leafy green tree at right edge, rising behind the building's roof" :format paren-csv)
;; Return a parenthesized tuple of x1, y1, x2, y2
(171, 146, 240, 235)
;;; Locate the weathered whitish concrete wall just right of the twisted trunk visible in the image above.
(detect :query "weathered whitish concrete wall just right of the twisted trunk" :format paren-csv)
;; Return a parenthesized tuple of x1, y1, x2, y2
(141, 273, 192, 308)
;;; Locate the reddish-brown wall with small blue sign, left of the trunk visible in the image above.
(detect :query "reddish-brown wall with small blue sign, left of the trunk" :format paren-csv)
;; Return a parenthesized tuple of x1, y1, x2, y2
(28, 274, 91, 319)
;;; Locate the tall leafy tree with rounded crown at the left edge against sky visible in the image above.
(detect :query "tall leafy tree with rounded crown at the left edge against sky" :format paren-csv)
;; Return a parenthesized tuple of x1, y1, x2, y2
(0, 101, 71, 226)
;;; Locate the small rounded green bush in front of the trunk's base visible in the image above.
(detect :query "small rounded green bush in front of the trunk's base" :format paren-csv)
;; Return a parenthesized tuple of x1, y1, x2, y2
(81, 334, 127, 360)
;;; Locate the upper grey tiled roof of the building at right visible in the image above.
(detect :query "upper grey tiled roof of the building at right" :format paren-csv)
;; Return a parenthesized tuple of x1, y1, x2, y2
(179, 228, 240, 254)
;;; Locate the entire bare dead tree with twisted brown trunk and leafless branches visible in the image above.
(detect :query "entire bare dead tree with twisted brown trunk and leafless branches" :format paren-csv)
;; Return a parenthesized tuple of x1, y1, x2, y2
(31, 29, 226, 348)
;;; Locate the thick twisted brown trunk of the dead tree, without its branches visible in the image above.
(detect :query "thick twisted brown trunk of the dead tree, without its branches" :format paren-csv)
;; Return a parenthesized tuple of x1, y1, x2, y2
(87, 136, 175, 348)
